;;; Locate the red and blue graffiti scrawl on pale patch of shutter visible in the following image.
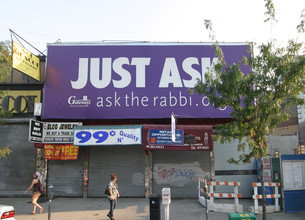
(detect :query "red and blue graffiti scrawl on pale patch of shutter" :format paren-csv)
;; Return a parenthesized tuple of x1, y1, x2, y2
(153, 163, 203, 186)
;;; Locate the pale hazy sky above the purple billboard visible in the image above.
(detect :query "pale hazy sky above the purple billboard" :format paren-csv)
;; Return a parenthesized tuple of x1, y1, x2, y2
(0, 0, 305, 54)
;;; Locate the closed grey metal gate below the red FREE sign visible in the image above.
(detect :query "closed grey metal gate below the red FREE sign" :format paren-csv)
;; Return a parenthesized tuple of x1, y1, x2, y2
(48, 148, 84, 197)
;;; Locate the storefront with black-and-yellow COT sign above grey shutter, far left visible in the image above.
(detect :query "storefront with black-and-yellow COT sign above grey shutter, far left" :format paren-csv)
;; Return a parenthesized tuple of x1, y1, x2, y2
(0, 84, 42, 197)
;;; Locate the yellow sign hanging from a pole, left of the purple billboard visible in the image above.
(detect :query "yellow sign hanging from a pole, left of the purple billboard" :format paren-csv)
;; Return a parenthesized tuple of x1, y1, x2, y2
(13, 41, 40, 81)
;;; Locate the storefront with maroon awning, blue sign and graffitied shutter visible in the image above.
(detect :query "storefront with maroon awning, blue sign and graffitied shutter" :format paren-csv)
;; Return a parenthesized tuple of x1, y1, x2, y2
(143, 125, 213, 198)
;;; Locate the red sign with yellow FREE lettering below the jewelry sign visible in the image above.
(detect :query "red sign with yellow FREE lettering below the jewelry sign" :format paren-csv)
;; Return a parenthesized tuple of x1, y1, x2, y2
(44, 144, 79, 160)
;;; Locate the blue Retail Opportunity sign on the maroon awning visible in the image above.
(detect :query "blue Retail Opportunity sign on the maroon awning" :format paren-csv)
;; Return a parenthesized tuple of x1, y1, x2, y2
(149, 129, 183, 146)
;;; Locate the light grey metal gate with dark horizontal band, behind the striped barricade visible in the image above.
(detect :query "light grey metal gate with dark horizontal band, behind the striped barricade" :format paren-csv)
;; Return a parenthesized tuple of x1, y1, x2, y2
(214, 141, 257, 198)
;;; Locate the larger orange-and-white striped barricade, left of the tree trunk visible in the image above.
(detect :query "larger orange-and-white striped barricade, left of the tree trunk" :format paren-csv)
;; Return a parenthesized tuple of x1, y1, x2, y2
(198, 178, 243, 212)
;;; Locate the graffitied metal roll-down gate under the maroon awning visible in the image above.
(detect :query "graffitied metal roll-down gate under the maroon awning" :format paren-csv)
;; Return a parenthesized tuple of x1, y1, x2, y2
(152, 151, 211, 198)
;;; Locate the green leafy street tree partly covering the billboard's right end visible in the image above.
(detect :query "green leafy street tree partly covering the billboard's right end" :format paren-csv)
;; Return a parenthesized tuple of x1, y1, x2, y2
(190, 0, 305, 220)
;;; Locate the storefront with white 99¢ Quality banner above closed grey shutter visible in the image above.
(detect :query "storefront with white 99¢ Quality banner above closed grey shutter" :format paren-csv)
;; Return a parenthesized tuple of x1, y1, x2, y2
(73, 125, 145, 197)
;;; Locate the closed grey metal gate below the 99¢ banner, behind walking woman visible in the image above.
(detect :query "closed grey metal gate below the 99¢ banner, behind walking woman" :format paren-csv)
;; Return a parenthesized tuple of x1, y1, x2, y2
(88, 145, 145, 197)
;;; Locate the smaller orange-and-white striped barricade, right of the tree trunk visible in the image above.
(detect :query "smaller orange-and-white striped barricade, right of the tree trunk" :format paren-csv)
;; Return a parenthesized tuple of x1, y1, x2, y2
(249, 182, 281, 213)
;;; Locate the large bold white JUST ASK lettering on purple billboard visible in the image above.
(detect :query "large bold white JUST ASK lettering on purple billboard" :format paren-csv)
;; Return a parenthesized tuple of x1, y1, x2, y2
(70, 57, 218, 89)
